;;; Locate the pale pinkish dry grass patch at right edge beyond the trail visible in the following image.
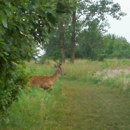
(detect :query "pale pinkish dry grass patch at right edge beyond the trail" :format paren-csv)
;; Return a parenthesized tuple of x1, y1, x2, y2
(95, 67, 130, 90)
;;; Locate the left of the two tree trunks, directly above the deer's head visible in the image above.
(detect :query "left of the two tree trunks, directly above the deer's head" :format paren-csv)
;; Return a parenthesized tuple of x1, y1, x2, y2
(58, 22, 65, 63)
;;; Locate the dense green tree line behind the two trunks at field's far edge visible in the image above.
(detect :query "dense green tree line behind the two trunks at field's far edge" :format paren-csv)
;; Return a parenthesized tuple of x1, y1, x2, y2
(41, 30, 130, 60)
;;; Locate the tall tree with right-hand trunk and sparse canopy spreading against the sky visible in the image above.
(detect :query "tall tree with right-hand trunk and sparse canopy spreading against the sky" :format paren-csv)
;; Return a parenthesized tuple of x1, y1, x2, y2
(71, 0, 125, 63)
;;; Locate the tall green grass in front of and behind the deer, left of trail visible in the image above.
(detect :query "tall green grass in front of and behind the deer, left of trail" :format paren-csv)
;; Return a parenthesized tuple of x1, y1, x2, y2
(0, 61, 63, 130)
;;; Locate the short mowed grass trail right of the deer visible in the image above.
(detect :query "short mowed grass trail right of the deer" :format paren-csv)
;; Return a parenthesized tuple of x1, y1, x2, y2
(60, 80, 130, 130)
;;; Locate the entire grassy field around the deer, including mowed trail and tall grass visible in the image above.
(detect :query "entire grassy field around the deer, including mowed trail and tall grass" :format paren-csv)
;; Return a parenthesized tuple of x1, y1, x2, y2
(0, 59, 130, 130)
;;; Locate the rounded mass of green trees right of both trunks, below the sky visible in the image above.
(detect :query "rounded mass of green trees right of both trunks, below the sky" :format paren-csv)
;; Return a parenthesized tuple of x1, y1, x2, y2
(76, 29, 130, 61)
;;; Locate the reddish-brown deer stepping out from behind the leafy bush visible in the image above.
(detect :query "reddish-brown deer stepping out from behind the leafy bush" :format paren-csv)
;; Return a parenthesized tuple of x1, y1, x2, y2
(30, 64, 66, 90)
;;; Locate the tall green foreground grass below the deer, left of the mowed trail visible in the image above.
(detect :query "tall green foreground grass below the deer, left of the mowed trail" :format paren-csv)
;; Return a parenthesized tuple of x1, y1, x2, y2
(7, 85, 62, 130)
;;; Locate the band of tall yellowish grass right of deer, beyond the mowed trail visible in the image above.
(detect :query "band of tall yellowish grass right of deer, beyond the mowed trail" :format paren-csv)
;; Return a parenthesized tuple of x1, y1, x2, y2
(61, 59, 130, 89)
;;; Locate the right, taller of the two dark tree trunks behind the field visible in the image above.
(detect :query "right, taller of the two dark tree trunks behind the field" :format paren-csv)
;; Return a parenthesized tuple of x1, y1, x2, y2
(70, 11, 76, 63)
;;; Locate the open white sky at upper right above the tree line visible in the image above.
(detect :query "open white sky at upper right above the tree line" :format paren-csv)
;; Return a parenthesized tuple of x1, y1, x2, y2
(108, 0, 130, 43)
